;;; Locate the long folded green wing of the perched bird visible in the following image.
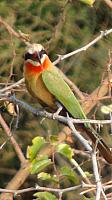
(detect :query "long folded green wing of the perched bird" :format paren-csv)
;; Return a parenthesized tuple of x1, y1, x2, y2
(42, 67, 86, 119)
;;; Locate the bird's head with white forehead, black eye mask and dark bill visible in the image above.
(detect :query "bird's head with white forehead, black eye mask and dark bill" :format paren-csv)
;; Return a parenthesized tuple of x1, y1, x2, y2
(25, 43, 47, 67)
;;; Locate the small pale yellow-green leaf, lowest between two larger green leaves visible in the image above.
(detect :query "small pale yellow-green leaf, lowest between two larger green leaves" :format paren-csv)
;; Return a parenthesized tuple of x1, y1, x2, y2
(37, 172, 59, 183)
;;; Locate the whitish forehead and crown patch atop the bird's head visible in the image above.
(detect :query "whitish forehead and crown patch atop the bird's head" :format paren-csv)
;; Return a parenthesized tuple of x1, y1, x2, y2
(26, 43, 44, 54)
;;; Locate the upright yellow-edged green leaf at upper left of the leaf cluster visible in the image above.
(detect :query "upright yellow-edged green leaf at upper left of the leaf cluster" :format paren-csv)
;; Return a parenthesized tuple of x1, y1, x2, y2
(27, 136, 46, 161)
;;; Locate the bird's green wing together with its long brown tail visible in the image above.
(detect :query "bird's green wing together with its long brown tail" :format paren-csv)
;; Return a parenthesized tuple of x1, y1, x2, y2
(42, 67, 112, 164)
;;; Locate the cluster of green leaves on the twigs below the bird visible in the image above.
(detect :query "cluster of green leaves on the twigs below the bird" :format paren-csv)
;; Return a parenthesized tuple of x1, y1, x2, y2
(27, 137, 79, 200)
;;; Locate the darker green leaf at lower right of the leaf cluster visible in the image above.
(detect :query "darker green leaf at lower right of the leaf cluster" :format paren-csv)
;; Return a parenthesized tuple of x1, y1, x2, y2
(60, 166, 80, 184)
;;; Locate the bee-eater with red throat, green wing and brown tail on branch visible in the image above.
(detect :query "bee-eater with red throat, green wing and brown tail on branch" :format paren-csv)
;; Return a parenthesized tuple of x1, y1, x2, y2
(24, 43, 112, 164)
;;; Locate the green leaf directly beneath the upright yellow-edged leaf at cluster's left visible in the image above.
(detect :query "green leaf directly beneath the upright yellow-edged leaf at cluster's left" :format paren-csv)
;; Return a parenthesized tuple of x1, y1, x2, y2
(31, 156, 51, 174)
